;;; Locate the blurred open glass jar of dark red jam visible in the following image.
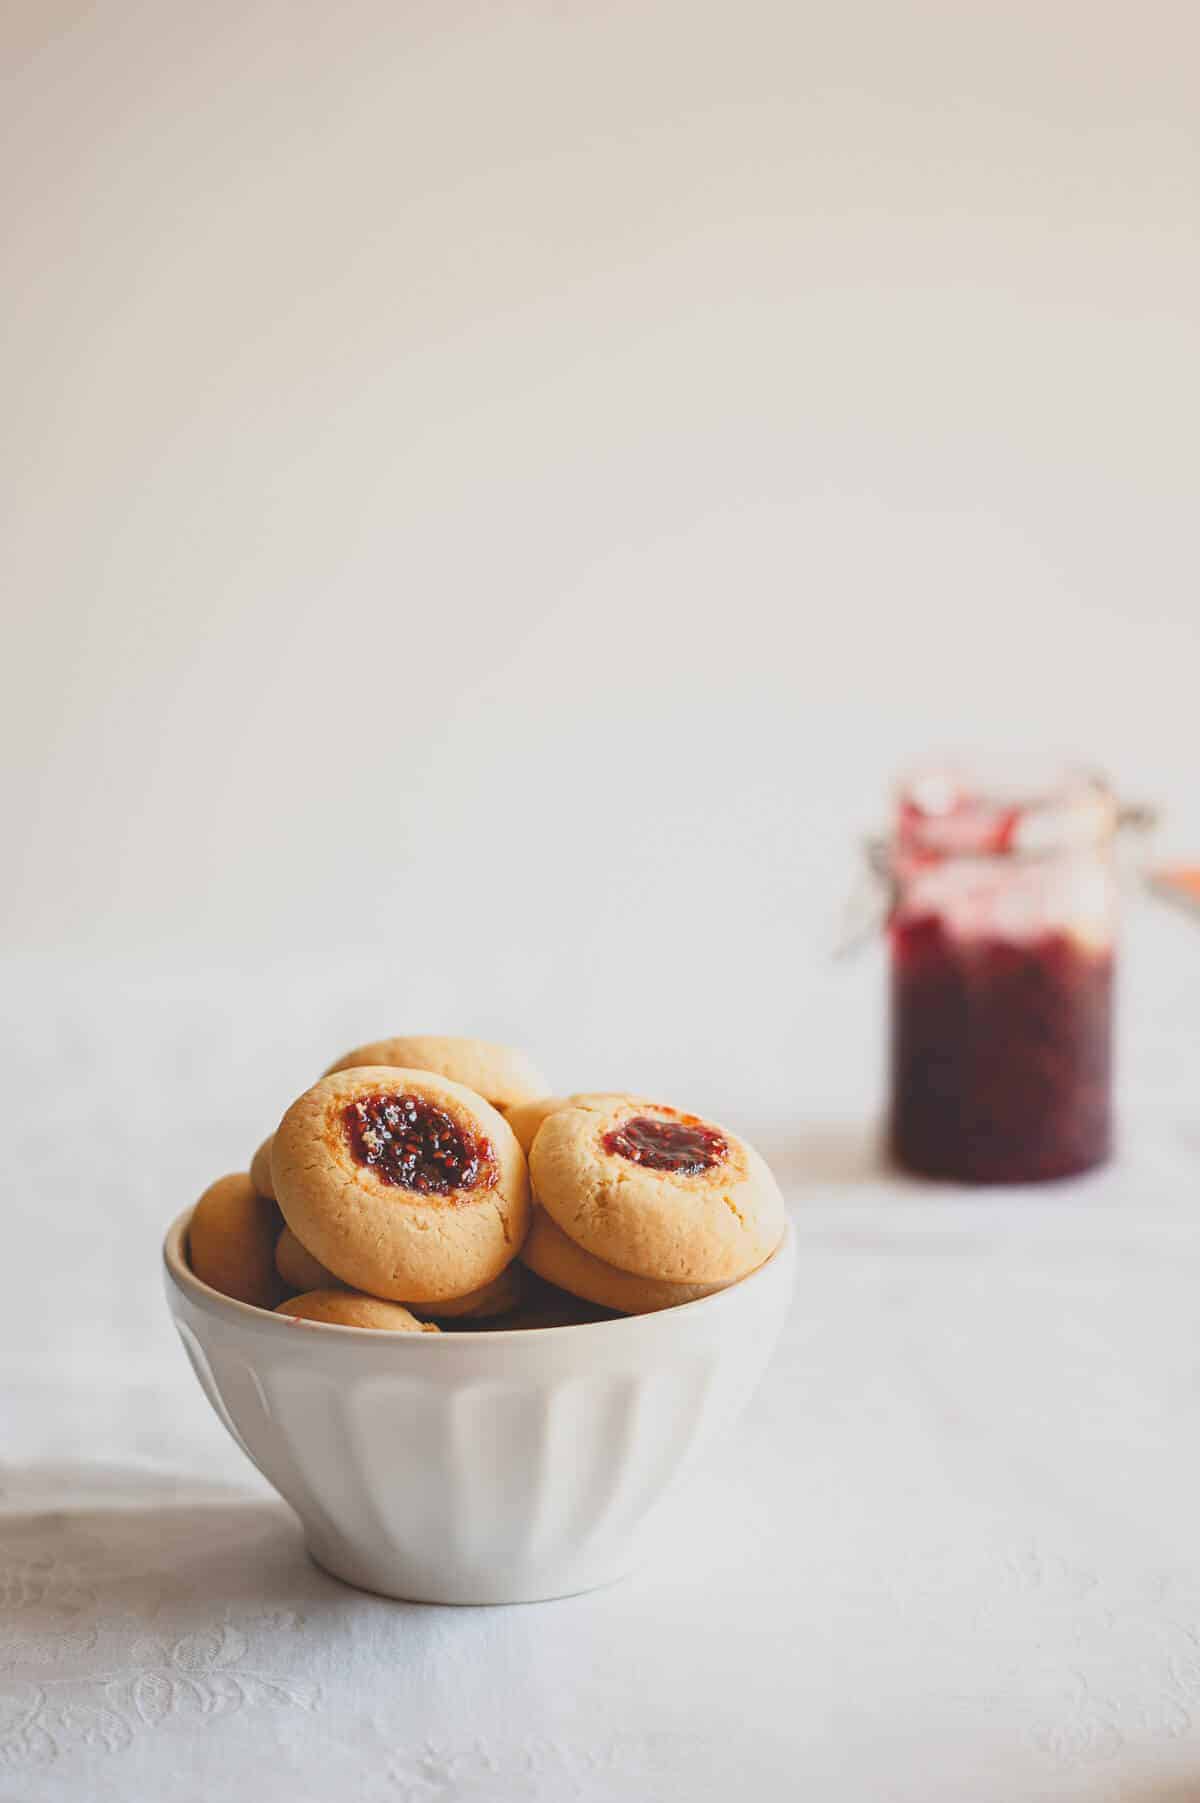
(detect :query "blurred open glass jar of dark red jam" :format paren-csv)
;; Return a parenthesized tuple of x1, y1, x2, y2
(885, 770, 1117, 1183)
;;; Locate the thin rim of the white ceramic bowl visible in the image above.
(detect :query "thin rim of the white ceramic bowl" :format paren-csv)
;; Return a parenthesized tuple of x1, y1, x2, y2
(162, 1204, 795, 1347)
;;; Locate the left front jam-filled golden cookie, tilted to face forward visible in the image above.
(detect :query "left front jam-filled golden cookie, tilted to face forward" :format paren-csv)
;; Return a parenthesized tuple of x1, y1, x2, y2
(272, 1066, 530, 1304)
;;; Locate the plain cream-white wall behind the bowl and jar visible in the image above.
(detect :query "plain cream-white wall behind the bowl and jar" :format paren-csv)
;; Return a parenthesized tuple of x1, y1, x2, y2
(0, 0, 1200, 1100)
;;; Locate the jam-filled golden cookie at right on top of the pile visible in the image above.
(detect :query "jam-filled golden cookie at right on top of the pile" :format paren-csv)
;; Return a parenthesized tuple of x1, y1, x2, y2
(530, 1102, 784, 1284)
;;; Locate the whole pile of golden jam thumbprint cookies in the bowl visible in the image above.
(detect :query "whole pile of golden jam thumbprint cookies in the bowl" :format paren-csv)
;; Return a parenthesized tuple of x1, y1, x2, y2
(189, 1035, 784, 1332)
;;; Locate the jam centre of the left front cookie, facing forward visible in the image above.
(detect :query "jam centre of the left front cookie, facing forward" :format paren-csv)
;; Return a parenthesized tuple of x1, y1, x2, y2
(342, 1096, 495, 1195)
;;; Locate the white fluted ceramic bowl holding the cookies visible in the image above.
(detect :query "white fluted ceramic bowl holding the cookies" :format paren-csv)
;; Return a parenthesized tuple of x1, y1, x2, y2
(164, 1212, 795, 1603)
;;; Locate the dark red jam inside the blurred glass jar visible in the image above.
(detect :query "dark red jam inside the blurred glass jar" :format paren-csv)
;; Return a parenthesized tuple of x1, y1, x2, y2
(890, 914, 1114, 1183)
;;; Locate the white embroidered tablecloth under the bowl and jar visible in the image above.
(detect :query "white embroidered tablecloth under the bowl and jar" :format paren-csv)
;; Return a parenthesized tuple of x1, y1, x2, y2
(0, 944, 1200, 1803)
